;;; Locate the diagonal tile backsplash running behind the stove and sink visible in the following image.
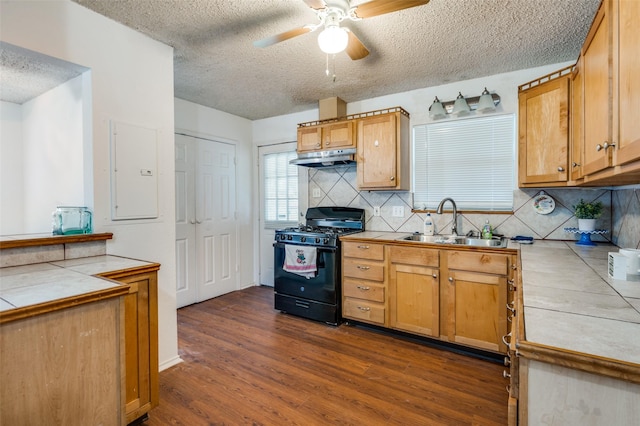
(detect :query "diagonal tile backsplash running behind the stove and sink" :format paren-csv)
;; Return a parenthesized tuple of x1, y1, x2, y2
(309, 165, 640, 248)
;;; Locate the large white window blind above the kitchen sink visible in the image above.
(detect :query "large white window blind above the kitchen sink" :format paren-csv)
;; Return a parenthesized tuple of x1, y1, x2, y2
(413, 114, 516, 211)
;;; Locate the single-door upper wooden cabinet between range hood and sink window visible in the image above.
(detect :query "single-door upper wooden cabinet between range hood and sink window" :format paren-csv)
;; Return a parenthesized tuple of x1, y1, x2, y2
(357, 108, 410, 190)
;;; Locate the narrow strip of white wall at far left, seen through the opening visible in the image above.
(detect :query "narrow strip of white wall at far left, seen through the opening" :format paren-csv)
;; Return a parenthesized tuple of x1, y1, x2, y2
(0, 102, 24, 235)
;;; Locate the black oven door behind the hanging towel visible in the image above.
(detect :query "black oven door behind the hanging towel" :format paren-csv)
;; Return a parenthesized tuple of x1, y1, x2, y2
(273, 242, 340, 305)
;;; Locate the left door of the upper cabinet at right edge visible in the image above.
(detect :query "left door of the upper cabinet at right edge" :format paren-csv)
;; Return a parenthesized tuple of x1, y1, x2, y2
(582, 0, 612, 175)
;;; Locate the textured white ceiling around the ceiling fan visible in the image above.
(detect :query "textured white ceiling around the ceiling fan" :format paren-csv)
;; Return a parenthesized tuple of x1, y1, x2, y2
(50, 0, 600, 119)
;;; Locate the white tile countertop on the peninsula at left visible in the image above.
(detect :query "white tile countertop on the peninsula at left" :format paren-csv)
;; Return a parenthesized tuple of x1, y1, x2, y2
(0, 255, 150, 312)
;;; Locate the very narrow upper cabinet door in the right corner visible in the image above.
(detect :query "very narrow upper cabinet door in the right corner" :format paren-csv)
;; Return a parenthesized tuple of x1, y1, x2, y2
(569, 58, 584, 181)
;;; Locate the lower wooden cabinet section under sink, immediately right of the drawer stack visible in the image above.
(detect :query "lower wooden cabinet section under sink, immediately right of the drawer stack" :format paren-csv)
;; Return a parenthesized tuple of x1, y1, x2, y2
(389, 246, 440, 337)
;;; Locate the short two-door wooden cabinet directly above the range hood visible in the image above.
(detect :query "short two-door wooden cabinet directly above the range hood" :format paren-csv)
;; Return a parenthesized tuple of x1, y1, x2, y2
(298, 120, 356, 152)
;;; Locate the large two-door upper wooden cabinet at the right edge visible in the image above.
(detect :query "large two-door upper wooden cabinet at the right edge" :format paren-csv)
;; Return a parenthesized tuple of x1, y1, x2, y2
(582, 0, 640, 185)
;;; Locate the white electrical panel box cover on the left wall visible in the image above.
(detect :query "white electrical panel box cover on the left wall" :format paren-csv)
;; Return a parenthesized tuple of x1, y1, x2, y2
(110, 121, 158, 220)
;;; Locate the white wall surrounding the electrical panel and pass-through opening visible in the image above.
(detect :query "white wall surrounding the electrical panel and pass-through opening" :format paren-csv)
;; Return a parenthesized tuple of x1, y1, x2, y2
(0, 0, 179, 368)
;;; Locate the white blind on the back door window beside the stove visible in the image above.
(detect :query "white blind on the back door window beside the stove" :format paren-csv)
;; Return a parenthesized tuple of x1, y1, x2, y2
(263, 151, 298, 228)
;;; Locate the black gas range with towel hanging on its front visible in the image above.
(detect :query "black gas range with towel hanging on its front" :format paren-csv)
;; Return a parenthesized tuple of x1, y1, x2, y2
(273, 207, 365, 325)
